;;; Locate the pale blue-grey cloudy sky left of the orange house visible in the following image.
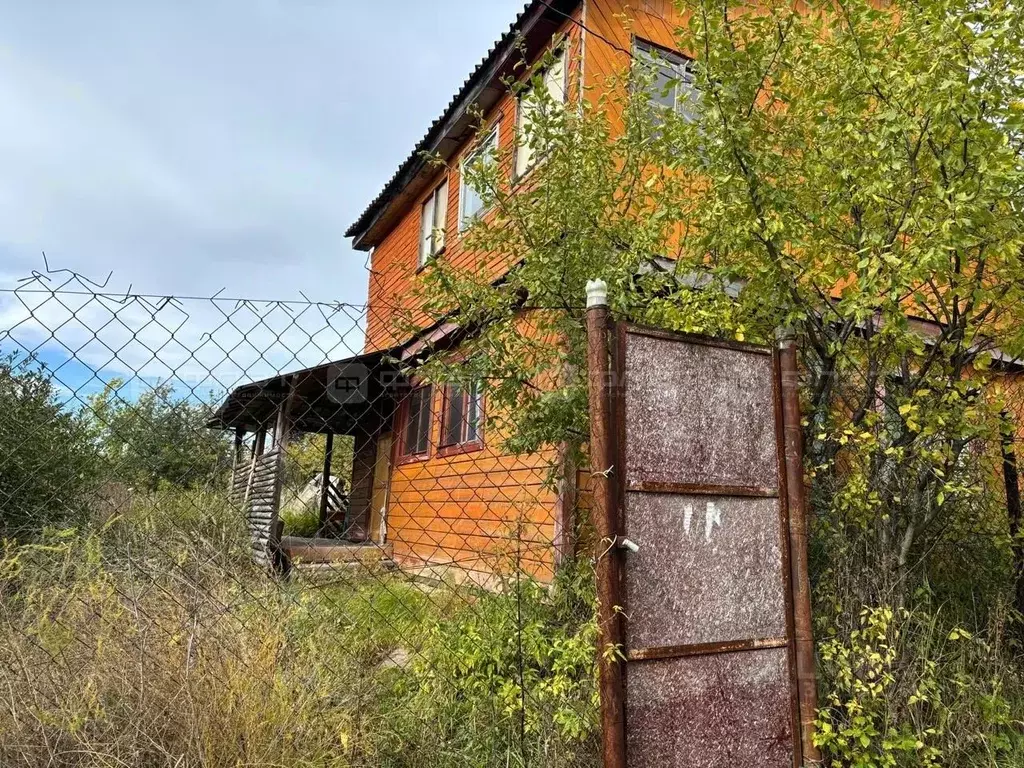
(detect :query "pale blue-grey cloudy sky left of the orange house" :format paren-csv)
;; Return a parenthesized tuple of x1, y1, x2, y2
(0, 0, 523, 403)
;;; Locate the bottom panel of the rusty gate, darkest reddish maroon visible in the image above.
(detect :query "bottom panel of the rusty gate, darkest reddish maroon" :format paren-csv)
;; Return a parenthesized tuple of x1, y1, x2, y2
(626, 648, 795, 768)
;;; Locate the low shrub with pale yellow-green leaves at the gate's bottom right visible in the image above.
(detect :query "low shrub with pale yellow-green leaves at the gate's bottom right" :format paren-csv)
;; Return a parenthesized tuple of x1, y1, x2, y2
(816, 605, 1024, 768)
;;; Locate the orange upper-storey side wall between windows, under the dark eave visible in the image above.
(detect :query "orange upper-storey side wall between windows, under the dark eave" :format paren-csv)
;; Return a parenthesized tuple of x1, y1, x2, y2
(367, 10, 583, 351)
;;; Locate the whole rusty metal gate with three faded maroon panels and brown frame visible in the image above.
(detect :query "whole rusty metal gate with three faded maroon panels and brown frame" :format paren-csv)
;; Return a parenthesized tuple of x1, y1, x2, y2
(590, 284, 817, 768)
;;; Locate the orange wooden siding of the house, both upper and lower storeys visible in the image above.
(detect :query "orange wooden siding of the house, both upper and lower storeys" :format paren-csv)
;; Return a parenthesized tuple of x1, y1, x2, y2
(367, 0, 678, 582)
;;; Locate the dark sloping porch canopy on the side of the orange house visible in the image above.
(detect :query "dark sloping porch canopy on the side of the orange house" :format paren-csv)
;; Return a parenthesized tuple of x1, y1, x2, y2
(207, 349, 408, 435)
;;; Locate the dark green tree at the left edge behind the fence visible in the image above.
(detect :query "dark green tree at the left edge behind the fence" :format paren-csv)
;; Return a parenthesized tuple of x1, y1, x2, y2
(0, 354, 98, 539)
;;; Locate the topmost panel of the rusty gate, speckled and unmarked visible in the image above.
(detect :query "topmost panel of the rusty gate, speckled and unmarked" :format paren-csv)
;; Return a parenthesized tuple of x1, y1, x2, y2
(624, 334, 778, 492)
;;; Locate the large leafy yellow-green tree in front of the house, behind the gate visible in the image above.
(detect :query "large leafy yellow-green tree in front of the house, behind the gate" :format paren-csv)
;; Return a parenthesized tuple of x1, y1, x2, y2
(409, 0, 1024, 765)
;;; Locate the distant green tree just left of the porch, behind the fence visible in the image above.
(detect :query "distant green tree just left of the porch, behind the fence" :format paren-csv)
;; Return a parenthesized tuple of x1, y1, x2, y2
(87, 379, 230, 490)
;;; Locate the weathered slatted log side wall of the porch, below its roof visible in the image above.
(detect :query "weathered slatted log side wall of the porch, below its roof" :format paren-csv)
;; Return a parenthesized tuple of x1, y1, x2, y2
(230, 451, 283, 568)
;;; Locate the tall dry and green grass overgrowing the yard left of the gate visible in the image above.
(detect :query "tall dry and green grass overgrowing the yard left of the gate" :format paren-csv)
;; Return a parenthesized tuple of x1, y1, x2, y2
(0, 490, 596, 768)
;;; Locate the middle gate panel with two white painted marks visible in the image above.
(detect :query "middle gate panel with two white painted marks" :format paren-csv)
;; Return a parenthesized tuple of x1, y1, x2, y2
(625, 494, 786, 655)
